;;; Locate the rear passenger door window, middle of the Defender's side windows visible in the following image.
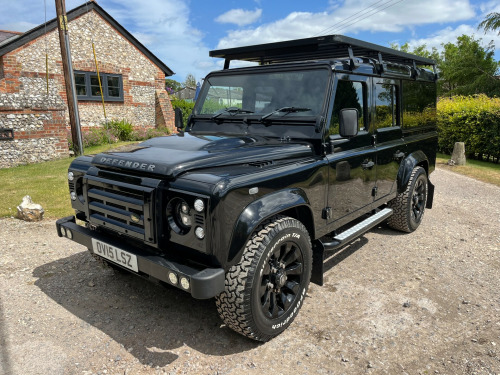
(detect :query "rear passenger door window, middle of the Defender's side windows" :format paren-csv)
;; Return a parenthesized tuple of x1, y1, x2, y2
(375, 83, 399, 129)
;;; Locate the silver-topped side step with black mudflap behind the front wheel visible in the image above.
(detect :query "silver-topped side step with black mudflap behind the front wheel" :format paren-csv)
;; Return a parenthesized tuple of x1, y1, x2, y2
(311, 208, 393, 286)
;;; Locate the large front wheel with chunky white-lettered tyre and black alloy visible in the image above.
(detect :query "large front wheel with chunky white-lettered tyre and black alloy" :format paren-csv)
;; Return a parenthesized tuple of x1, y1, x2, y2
(216, 216, 312, 341)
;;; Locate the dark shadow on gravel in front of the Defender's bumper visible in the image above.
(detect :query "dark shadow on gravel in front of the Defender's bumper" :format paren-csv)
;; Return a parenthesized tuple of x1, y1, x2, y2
(33, 252, 259, 367)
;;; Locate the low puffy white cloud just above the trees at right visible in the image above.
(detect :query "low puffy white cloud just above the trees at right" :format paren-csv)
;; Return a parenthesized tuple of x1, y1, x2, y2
(408, 25, 500, 51)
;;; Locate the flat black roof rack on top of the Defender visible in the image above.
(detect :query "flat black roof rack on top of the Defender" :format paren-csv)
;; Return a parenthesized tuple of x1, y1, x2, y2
(210, 35, 436, 67)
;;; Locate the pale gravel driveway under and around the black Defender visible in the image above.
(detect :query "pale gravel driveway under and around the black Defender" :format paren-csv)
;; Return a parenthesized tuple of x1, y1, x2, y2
(0, 169, 500, 375)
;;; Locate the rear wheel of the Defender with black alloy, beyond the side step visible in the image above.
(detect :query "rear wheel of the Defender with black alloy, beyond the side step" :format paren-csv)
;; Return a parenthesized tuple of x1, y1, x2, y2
(387, 167, 428, 233)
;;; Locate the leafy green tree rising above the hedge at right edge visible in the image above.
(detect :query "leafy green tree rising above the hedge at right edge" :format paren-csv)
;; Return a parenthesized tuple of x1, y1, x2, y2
(438, 35, 500, 96)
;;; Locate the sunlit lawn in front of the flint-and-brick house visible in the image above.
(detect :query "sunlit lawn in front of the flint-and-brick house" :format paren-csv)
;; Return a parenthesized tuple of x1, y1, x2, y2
(0, 142, 135, 218)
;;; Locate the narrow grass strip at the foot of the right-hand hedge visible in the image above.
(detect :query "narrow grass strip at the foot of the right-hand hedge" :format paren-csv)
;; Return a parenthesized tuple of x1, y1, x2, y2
(436, 154, 500, 186)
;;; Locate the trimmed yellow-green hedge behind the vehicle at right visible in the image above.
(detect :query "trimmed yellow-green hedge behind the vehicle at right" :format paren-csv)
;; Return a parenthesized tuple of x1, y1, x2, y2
(437, 95, 500, 163)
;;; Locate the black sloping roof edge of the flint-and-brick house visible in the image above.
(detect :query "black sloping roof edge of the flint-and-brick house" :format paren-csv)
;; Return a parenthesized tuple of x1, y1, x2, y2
(0, 1, 174, 76)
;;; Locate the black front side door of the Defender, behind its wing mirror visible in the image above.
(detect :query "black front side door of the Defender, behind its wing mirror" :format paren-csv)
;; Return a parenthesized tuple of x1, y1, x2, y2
(327, 74, 376, 223)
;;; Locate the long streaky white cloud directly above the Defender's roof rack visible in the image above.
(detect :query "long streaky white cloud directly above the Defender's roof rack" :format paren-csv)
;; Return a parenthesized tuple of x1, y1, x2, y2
(218, 0, 475, 48)
